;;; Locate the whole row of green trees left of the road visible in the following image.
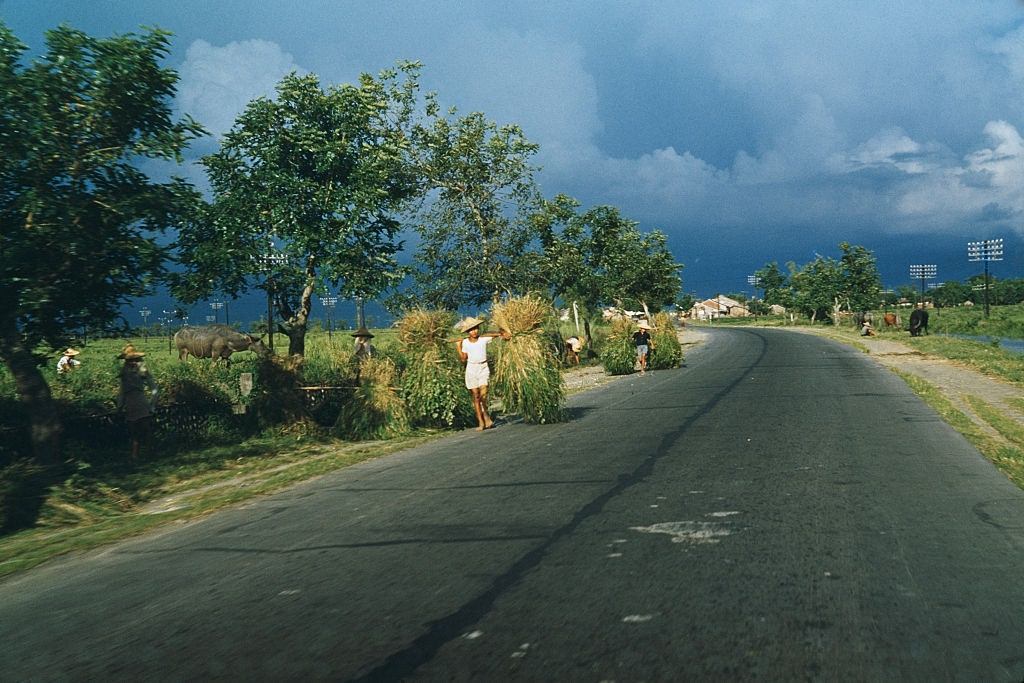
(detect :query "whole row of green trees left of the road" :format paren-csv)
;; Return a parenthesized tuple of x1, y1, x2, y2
(0, 24, 681, 464)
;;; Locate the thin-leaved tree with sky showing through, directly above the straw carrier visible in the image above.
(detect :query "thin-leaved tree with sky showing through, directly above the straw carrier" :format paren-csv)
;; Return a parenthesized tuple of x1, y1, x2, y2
(403, 109, 539, 309)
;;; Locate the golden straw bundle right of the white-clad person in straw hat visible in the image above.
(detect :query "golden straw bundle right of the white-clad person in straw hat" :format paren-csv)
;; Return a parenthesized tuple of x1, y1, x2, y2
(490, 296, 565, 424)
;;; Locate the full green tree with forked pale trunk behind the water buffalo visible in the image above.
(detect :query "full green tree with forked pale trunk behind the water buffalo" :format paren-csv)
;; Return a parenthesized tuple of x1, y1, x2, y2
(175, 63, 421, 355)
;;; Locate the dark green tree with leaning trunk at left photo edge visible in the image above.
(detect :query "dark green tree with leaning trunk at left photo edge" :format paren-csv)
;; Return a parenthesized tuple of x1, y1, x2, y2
(0, 24, 203, 465)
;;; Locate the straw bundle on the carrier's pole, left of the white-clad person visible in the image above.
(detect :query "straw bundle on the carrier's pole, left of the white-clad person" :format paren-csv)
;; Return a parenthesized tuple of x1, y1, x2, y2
(397, 308, 475, 429)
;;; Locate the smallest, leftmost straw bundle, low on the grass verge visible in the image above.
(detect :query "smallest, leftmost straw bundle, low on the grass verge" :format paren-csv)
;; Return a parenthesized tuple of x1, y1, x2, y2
(334, 355, 410, 441)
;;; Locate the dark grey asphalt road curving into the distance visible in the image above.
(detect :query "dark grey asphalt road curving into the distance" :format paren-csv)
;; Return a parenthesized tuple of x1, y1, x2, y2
(0, 330, 1024, 682)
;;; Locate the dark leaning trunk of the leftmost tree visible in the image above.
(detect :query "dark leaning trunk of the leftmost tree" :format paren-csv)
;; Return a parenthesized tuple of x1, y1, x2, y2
(3, 332, 63, 468)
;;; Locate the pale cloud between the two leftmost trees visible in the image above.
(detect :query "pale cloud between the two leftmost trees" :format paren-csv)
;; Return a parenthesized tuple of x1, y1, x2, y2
(177, 40, 304, 136)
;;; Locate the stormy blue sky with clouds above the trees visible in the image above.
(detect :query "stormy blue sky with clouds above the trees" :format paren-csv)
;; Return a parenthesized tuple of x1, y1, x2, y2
(0, 0, 1024, 321)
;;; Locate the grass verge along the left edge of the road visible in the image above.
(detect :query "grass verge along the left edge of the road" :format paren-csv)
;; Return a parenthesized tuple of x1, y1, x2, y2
(0, 431, 451, 578)
